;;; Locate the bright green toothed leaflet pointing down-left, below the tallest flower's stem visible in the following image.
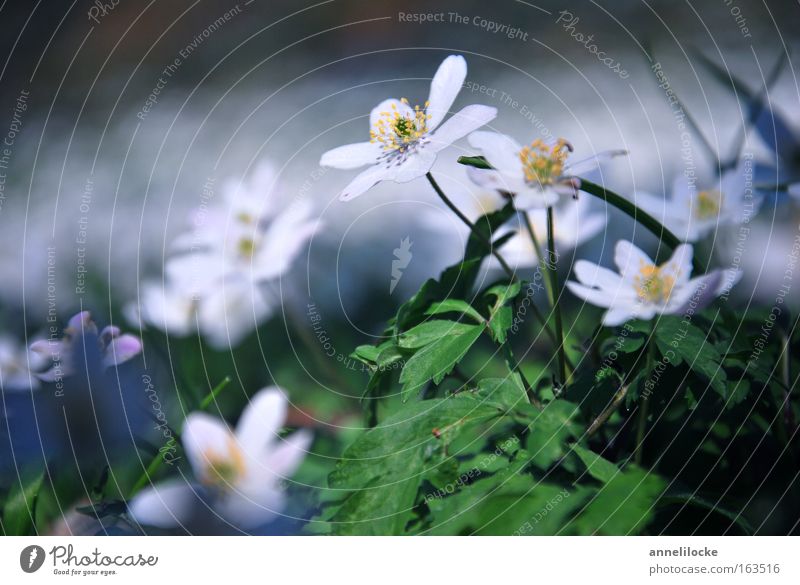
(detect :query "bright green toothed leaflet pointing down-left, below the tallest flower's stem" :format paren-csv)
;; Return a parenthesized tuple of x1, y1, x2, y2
(400, 324, 483, 402)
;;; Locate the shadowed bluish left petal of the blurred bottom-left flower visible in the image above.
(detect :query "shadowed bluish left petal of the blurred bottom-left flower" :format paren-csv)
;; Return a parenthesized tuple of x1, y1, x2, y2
(128, 480, 200, 528)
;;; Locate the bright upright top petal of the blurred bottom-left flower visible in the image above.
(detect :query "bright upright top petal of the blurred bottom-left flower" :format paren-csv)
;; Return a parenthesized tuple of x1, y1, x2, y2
(236, 386, 289, 456)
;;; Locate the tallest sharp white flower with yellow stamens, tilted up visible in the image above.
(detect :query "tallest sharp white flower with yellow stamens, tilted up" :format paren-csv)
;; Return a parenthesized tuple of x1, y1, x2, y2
(320, 55, 497, 201)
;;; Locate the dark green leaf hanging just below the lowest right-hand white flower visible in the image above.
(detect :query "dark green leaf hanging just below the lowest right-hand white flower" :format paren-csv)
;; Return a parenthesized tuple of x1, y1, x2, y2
(655, 317, 728, 400)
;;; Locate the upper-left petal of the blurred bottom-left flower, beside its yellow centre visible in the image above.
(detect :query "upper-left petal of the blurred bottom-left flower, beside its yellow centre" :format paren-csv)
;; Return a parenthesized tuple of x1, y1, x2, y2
(181, 412, 237, 479)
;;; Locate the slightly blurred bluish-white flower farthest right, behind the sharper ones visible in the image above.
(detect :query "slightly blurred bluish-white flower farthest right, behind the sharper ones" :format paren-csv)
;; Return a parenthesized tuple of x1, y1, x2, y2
(634, 160, 762, 242)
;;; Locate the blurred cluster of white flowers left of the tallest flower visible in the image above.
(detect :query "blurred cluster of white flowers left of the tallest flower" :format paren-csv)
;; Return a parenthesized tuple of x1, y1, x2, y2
(127, 164, 320, 349)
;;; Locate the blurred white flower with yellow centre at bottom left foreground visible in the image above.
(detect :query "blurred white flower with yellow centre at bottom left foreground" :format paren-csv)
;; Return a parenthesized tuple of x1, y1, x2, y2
(128, 387, 312, 529)
